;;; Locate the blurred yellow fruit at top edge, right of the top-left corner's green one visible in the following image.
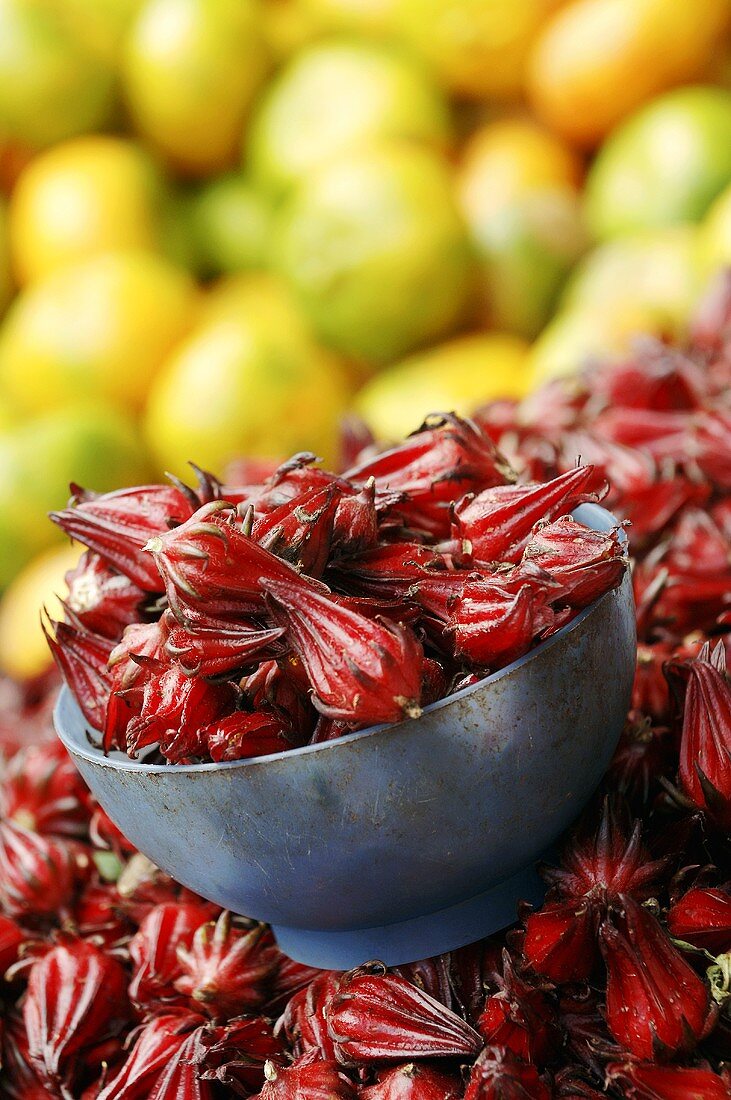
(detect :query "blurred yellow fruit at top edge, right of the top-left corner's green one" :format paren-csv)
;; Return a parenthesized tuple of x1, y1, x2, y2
(122, 0, 267, 176)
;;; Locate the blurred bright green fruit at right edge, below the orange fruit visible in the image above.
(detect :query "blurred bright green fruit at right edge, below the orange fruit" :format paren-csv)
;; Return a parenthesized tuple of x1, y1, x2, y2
(586, 87, 731, 240)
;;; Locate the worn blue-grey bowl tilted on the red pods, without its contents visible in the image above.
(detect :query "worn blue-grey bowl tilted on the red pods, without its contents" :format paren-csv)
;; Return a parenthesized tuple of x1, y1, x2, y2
(56, 505, 635, 968)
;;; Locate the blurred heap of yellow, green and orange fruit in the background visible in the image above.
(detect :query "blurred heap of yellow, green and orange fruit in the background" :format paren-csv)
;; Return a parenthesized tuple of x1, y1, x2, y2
(0, 0, 731, 677)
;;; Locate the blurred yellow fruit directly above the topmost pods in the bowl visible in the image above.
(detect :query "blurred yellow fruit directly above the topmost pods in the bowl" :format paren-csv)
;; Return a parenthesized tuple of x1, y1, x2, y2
(355, 332, 532, 440)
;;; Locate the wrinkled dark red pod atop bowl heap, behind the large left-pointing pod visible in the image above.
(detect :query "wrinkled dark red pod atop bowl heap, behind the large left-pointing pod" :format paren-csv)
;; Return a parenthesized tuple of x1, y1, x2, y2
(252, 484, 342, 576)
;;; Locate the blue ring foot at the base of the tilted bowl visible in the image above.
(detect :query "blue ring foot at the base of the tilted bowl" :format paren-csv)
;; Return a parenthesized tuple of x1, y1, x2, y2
(272, 864, 545, 970)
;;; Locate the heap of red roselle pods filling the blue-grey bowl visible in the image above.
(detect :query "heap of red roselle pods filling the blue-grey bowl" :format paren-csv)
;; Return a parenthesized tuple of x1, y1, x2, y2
(42, 416, 627, 763)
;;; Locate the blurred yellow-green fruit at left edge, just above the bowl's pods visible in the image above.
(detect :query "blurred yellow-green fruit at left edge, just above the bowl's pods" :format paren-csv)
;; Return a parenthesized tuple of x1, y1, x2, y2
(0, 402, 148, 589)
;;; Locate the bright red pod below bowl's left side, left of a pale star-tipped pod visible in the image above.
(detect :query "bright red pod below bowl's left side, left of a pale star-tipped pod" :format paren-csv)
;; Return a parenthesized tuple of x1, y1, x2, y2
(130, 902, 211, 1009)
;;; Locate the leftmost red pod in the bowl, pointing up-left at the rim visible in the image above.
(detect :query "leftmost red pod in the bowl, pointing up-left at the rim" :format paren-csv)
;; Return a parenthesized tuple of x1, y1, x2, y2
(42, 619, 113, 729)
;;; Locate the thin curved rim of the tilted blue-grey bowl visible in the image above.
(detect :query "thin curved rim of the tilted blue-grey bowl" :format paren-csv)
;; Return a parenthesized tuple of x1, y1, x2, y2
(54, 504, 630, 776)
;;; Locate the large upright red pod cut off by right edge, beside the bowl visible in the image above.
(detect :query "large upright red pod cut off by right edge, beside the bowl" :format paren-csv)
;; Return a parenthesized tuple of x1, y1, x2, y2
(666, 642, 731, 829)
